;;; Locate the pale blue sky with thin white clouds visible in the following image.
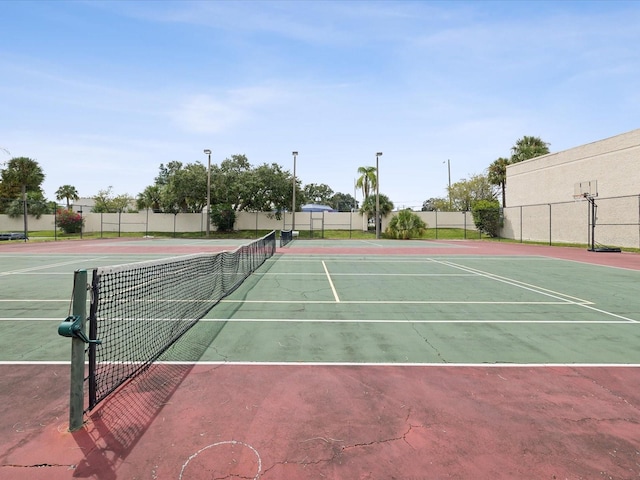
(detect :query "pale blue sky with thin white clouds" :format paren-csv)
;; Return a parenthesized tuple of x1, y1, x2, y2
(0, 0, 640, 209)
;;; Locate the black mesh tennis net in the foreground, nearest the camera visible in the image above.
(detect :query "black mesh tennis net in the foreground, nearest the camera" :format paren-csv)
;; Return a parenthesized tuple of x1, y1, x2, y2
(85, 231, 276, 411)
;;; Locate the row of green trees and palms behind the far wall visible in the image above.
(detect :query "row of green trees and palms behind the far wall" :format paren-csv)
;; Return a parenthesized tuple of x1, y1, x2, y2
(0, 136, 549, 234)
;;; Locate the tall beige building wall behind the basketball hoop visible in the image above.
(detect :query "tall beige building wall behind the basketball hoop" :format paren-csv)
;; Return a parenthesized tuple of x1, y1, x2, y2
(501, 129, 640, 248)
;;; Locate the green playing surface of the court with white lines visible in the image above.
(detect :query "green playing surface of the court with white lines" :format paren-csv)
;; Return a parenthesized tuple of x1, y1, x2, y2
(0, 248, 640, 365)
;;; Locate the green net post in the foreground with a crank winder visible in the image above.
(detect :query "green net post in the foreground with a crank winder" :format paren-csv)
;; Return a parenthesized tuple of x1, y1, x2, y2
(69, 270, 87, 432)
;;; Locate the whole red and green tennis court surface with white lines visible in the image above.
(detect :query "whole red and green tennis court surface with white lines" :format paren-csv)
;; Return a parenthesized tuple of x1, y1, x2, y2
(0, 239, 640, 480)
